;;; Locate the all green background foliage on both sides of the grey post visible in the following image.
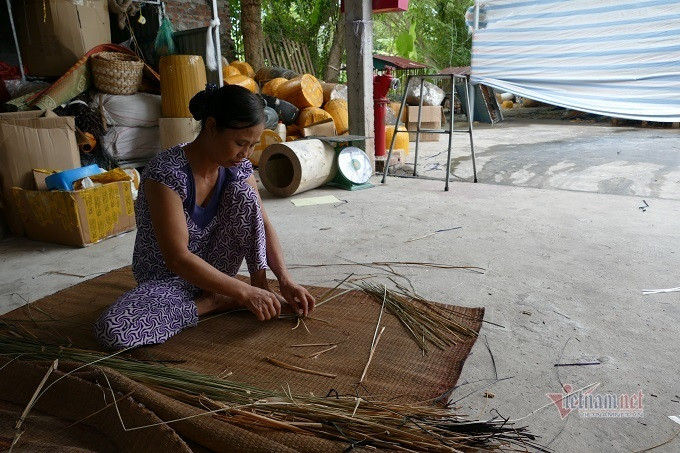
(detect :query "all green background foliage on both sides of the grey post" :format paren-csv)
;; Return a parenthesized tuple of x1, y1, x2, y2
(228, 0, 473, 75)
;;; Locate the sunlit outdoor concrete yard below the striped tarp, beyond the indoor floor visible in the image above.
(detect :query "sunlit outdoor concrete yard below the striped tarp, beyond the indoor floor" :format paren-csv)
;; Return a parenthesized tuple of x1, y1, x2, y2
(390, 118, 680, 199)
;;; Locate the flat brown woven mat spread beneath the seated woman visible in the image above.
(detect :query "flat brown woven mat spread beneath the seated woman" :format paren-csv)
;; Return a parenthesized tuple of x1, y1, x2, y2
(0, 267, 484, 451)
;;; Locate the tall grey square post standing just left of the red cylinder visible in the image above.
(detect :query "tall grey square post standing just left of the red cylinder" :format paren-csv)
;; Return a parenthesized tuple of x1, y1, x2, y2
(345, 0, 375, 170)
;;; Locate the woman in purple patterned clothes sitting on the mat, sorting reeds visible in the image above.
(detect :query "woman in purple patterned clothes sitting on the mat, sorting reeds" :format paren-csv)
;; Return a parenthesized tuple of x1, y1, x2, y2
(94, 85, 314, 349)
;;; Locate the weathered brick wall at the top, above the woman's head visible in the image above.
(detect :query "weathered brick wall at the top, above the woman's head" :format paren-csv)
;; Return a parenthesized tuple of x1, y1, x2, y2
(165, 0, 233, 61)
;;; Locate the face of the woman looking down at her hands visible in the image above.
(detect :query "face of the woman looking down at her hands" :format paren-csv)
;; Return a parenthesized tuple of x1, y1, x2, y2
(211, 120, 264, 167)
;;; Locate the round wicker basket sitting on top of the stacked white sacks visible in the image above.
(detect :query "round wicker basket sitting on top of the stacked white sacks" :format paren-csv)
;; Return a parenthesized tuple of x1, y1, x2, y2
(90, 52, 144, 94)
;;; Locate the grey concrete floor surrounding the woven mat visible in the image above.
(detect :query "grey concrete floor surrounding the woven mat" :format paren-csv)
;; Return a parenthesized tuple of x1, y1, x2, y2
(0, 120, 680, 452)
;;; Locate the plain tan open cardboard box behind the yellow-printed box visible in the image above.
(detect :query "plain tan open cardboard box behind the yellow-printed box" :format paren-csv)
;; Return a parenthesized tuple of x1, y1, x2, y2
(0, 110, 80, 236)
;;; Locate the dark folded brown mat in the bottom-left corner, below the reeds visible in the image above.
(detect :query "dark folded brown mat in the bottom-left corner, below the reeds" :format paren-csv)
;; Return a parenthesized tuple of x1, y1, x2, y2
(0, 357, 191, 452)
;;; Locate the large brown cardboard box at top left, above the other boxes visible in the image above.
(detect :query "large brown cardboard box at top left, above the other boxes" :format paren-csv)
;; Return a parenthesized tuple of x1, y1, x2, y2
(13, 0, 111, 77)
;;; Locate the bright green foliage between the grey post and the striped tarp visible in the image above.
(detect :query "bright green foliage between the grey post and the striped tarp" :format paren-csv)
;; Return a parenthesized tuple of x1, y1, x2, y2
(373, 0, 473, 70)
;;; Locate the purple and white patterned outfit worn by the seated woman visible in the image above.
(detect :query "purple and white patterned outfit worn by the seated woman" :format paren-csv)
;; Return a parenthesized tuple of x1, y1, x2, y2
(94, 144, 267, 349)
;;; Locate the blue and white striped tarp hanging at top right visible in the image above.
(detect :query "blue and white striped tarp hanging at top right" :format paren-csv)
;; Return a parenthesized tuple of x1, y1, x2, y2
(467, 0, 680, 122)
